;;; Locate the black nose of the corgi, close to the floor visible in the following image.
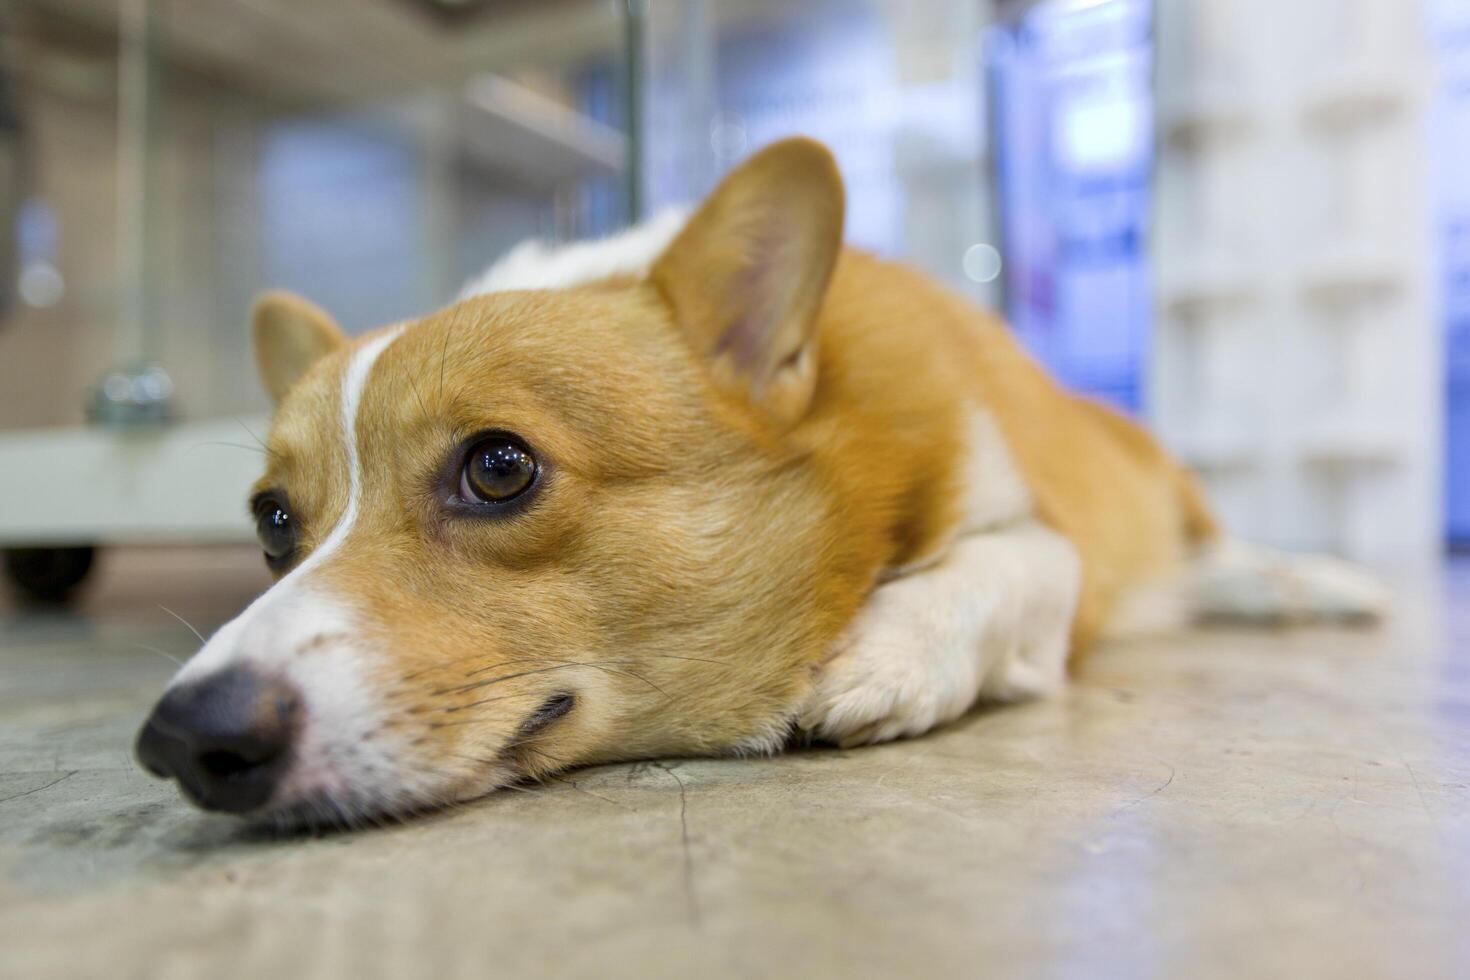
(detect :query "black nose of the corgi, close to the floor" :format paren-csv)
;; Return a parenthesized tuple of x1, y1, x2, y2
(137, 667, 298, 813)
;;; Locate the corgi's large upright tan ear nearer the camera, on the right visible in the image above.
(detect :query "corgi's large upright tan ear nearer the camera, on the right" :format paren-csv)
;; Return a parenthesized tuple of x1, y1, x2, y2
(650, 138, 842, 426)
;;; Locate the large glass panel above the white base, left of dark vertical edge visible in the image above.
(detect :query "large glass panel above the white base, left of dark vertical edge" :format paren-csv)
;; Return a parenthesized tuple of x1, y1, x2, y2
(0, 0, 626, 429)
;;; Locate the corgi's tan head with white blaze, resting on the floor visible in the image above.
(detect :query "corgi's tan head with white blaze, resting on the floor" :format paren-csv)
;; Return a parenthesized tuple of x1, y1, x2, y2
(138, 141, 872, 820)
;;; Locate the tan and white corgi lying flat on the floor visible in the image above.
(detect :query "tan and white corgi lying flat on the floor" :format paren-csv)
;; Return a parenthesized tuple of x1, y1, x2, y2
(137, 138, 1383, 823)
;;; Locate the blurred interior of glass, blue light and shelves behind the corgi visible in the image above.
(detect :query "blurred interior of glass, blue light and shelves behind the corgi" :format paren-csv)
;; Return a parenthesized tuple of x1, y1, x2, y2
(0, 0, 1470, 598)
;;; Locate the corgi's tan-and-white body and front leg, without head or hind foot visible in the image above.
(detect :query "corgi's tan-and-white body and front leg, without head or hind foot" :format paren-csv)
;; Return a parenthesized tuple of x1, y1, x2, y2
(465, 221, 1214, 748)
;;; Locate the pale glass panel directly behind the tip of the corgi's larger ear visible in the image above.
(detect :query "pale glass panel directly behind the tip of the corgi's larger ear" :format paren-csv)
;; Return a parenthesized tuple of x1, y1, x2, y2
(645, 0, 998, 307)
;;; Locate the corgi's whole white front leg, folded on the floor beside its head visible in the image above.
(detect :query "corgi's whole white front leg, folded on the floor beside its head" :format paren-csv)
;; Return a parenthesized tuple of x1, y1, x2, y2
(798, 522, 1080, 746)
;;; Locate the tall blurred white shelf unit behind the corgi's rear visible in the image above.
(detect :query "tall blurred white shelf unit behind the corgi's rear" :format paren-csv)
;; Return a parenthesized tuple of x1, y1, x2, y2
(1151, 0, 1442, 566)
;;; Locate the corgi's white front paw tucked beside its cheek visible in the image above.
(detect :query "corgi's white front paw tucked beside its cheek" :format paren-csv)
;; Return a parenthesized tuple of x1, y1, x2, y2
(797, 586, 976, 748)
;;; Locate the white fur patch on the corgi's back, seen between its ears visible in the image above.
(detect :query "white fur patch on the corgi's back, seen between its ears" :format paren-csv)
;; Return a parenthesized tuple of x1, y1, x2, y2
(460, 209, 688, 300)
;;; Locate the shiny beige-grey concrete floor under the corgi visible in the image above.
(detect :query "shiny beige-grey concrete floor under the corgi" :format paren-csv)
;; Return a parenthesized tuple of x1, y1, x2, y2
(0, 550, 1470, 980)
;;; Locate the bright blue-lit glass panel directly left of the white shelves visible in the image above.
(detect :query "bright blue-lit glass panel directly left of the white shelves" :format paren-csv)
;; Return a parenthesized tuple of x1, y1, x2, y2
(991, 0, 1154, 408)
